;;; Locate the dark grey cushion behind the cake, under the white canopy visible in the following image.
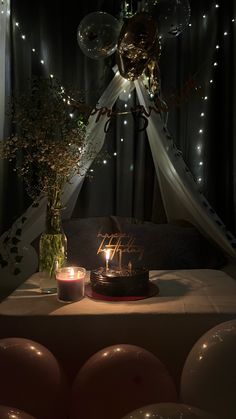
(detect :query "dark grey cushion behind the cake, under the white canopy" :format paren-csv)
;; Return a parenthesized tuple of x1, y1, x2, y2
(64, 216, 226, 269)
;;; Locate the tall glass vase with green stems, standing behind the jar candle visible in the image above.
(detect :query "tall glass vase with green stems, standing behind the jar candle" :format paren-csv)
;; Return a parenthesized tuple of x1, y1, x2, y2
(39, 203, 67, 294)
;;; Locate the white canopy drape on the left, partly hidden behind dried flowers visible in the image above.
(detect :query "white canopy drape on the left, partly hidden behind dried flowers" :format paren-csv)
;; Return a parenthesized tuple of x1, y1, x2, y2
(0, 73, 129, 287)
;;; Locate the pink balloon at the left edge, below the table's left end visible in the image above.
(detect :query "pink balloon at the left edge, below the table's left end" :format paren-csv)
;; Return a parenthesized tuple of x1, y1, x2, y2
(0, 338, 68, 419)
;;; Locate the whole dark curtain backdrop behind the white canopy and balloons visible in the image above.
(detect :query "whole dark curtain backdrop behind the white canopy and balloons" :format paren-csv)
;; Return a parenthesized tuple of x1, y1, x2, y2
(1, 0, 236, 236)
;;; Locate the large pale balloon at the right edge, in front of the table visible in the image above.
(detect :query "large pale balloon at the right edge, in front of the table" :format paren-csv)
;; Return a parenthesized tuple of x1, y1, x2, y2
(180, 319, 236, 419)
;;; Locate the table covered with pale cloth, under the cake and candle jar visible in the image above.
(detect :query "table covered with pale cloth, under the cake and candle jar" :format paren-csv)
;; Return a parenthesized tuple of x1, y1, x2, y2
(0, 269, 236, 385)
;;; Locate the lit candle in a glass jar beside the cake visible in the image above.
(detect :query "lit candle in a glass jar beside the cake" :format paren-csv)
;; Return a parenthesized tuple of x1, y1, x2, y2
(56, 266, 86, 303)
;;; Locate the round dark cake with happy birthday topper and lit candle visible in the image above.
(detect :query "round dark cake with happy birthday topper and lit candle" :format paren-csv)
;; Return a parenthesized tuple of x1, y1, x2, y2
(90, 233, 149, 297)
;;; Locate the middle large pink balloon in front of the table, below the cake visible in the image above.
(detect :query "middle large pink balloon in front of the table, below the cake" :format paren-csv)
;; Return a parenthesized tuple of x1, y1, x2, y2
(70, 345, 177, 419)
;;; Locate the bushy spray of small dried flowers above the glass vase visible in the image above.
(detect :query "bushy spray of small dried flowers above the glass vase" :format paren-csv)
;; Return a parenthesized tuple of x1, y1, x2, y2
(0, 79, 95, 205)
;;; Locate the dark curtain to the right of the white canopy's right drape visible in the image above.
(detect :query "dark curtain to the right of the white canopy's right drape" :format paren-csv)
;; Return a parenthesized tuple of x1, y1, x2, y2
(160, 0, 236, 233)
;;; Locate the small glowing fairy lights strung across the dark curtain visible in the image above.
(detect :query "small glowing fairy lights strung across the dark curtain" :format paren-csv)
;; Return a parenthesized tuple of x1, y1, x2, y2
(0, 0, 236, 180)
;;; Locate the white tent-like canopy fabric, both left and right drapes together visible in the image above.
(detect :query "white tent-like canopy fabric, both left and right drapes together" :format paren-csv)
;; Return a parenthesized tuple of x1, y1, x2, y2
(0, 65, 235, 284)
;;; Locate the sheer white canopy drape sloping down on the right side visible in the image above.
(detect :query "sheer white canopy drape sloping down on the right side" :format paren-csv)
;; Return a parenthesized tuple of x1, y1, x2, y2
(135, 80, 236, 257)
